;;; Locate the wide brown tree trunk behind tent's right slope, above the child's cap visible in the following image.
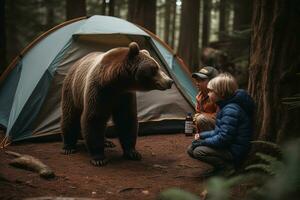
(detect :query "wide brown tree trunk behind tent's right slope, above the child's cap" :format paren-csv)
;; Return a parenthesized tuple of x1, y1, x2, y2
(178, 0, 200, 71)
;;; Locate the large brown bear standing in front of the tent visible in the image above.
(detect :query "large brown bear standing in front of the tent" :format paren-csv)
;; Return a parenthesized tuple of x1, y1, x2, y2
(61, 42, 173, 166)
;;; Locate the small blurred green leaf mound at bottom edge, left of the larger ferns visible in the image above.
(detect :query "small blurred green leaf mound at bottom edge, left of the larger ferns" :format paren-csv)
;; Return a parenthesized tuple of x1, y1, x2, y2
(156, 188, 200, 200)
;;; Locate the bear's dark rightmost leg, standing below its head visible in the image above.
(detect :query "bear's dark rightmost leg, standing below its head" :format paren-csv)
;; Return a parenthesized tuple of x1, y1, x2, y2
(113, 92, 142, 160)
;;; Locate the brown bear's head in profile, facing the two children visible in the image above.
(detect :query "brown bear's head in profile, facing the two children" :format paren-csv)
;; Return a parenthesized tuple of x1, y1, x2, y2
(128, 42, 173, 91)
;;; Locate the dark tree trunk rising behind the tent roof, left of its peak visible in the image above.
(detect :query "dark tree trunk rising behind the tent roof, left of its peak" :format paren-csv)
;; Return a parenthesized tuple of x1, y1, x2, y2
(66, 0, 86, 20)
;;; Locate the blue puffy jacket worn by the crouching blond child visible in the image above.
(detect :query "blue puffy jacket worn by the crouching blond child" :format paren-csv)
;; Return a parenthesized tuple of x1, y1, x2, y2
(192, 90, 254, 165)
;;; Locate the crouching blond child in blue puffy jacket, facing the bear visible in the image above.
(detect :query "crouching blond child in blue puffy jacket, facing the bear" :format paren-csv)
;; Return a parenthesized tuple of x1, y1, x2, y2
(187, 73, 254, 175)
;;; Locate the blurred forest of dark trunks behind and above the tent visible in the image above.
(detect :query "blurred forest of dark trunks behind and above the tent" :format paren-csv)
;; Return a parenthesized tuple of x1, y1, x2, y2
(0, 0, 252, 87)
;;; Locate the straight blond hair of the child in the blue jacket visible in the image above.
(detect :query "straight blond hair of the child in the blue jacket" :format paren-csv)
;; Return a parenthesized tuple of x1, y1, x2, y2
(207, 73, 238, 99)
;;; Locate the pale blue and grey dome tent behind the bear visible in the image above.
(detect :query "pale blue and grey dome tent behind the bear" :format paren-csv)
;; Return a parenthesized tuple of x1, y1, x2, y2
(0, 16, 197, 142)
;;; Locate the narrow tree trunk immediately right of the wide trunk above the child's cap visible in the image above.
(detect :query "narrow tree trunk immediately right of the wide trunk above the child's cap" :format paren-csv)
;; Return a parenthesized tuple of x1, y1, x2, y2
(202, 0, 211, 48)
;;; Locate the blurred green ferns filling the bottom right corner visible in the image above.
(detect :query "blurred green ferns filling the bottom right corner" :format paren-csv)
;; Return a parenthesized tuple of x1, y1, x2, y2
(158, 139, 300, 200)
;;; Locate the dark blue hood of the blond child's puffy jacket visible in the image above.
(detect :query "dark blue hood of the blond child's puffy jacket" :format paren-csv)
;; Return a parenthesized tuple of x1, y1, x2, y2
(217, 89, 255, 116)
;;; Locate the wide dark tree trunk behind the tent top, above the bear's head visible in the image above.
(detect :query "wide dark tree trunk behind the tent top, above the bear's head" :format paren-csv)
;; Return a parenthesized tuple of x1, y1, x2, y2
(128, 0, 156, 33)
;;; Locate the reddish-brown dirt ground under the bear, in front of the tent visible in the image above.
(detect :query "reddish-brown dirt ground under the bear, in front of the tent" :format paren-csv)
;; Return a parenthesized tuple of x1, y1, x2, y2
(0, 134, 210, 200)
